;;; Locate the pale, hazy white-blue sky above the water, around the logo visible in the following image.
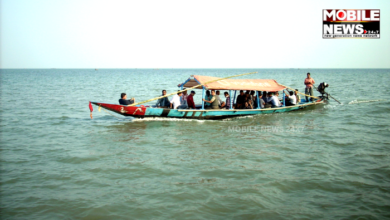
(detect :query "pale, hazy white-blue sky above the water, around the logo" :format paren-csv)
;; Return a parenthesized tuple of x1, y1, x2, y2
(0, 0, 390, 69)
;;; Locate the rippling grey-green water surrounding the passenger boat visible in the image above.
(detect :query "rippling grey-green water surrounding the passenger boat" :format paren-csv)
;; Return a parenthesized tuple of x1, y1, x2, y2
(0, 69, 390, 219)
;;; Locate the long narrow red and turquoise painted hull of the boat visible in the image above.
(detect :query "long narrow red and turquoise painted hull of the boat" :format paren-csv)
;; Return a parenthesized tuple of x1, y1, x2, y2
(91, 100, 325, 120)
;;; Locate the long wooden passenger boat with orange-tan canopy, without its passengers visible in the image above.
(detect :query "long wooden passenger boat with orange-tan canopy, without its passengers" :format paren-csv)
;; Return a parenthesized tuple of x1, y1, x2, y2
(90, 75, 327, 120)
